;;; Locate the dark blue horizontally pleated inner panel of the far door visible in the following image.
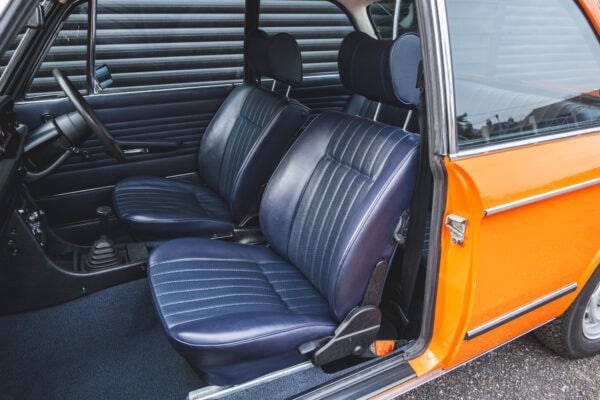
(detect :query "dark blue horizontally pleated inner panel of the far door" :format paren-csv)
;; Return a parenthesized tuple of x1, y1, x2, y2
(16, 85, 233, 223)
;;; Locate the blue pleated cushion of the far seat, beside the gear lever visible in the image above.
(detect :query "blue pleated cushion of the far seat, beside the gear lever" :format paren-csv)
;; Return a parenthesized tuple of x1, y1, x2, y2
(113, 177, 234, 240)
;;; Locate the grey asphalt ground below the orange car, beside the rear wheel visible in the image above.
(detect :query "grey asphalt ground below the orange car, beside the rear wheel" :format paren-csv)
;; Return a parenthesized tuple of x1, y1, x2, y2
(401, 335, 600, 400)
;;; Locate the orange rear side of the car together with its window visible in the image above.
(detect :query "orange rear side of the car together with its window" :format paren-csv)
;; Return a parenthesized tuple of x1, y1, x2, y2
(414, 0, 600, 371)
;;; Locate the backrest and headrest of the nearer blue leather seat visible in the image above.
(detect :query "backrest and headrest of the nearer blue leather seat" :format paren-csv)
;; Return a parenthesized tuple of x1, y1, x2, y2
(260, 32, 421, 320)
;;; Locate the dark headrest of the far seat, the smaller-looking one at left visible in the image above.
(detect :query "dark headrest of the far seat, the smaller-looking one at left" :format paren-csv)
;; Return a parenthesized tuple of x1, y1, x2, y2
(245, 30, 302, 85)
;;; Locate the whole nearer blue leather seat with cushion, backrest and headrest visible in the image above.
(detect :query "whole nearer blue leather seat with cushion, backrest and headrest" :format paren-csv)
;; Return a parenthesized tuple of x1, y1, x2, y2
(148, 33, 420, 385)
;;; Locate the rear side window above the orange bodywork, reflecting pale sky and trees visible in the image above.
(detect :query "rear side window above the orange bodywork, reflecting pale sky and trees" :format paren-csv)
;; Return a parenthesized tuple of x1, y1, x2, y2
(447, 0, 600, 149)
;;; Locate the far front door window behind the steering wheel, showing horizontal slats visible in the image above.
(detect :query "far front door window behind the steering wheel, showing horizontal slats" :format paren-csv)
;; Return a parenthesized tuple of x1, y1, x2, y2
(26, 0, 244, 98)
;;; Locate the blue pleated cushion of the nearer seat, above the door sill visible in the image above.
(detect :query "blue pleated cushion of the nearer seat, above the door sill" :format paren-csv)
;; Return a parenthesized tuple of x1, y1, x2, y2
(148, 238, 337, 385)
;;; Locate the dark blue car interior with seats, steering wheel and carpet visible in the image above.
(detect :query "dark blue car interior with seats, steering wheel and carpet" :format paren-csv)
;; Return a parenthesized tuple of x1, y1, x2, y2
(0, 0, 433, 399)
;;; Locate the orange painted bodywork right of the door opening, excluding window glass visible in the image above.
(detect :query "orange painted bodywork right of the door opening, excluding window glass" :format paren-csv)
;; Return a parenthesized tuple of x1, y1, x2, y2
(384, 0, 600, 397)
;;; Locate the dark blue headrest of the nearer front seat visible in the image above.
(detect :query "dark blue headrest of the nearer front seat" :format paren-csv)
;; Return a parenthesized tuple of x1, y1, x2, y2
(338, 31, 421, 108)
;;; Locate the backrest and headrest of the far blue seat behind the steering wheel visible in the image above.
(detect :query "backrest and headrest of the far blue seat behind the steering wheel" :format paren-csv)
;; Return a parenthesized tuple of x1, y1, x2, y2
(198, 31, 308, 222)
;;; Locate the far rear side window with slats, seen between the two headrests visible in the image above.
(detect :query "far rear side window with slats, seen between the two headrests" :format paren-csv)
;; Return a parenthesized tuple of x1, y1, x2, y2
(259, 0, 354, 76)
